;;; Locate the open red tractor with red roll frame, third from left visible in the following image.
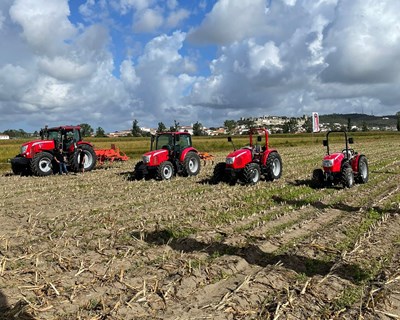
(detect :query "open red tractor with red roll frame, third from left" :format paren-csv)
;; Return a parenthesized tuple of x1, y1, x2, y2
(212, 128, 282, 184)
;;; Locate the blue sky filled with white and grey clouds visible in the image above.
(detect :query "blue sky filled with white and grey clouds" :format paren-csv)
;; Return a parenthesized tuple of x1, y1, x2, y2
(0, 0, 400, 131)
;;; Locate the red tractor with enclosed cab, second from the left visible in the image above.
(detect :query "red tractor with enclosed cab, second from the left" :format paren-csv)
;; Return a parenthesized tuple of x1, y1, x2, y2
(134, 132, 200, 180)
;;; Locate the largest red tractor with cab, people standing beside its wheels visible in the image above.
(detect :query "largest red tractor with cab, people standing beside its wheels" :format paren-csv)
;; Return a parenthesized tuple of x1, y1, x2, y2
(11, 126, 96, 176)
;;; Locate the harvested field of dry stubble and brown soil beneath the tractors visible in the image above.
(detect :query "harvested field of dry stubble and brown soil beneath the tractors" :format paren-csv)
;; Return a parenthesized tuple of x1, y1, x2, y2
(0, 136, 400, 320)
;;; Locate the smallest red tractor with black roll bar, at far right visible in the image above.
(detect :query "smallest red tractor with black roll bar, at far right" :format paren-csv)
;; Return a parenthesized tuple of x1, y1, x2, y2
(311, 130, 368, 188)
